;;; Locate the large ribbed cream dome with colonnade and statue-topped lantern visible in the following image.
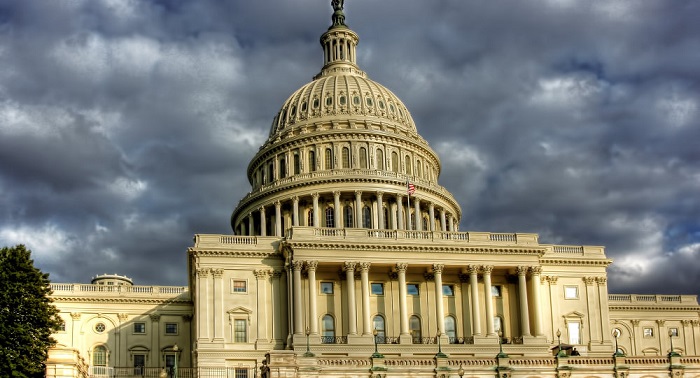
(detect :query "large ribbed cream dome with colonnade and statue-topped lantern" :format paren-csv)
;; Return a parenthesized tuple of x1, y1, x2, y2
(231, 6, 461, 236)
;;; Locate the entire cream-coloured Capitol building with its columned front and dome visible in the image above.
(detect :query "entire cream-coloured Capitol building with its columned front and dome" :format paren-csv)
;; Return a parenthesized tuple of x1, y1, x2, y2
(46, 1, 700, 378)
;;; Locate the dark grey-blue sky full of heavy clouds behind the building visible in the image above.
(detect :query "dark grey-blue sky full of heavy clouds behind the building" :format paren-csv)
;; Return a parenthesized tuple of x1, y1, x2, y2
(0, 0, 700, 294)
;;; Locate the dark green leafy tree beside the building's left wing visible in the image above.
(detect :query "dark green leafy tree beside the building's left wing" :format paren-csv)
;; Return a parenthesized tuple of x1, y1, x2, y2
(0, 245, 62, 377)
